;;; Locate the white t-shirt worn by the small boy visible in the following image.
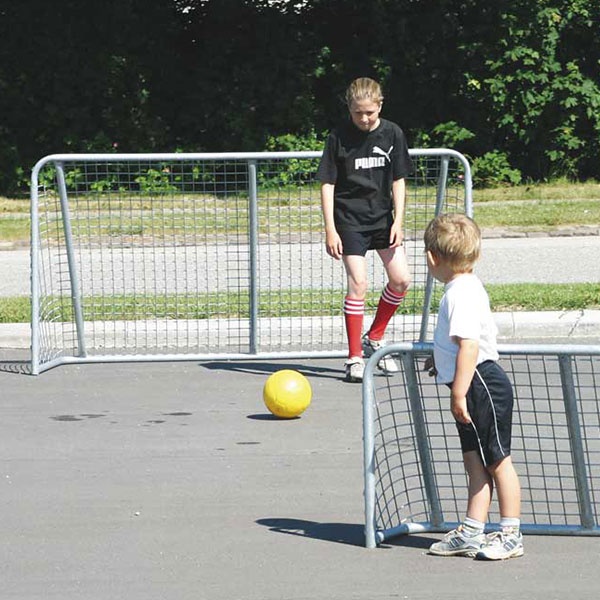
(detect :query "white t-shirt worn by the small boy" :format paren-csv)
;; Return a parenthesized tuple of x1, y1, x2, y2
(433, 273, 498, 383)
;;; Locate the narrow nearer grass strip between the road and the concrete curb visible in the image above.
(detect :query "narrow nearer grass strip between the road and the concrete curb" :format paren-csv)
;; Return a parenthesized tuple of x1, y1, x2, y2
(0, 283, 600, 323)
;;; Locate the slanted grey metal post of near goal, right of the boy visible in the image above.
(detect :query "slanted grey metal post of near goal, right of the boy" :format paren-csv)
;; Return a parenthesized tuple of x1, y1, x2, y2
(558, 354, 595, 529)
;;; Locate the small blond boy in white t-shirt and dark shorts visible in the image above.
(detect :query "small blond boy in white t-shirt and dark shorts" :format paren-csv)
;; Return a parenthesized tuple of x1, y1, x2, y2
(424, 214, 523, 560)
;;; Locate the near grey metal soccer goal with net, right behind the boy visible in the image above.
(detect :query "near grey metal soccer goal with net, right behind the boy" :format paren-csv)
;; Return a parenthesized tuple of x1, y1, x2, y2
(362, 342, 600, 548)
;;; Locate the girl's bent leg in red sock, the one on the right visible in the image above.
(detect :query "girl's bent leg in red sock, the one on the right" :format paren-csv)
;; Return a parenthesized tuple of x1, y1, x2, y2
(369, 248, 410, 341)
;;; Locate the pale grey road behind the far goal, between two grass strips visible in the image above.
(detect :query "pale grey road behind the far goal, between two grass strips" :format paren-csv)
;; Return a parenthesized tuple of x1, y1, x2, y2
(0, 235, 600, 297)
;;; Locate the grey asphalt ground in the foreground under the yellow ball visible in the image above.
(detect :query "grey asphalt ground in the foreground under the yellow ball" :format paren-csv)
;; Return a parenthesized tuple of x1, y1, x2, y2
(0, 351, 600, 600)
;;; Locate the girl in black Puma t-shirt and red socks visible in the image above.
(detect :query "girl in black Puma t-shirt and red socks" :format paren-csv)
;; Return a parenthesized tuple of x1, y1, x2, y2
(317, 77, 412, 382)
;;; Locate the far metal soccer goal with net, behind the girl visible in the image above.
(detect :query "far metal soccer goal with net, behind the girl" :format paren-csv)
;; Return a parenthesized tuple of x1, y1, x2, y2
(31, 149, 472, 374)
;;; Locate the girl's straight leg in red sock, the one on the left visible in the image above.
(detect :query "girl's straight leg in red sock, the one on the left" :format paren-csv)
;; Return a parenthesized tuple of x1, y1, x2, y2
(343, 255, 367, 358)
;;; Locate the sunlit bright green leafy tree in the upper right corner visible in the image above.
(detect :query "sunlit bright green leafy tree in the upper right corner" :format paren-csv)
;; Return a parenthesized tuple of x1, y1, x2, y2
(466, 0, 600, 178)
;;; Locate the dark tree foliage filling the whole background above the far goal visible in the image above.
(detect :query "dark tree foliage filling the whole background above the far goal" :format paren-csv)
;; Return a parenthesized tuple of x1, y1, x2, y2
(0, 0, 600, 193)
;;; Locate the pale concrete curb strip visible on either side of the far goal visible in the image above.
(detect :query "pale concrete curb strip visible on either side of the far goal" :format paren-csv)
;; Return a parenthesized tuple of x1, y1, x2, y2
(0, 310, 600, 350)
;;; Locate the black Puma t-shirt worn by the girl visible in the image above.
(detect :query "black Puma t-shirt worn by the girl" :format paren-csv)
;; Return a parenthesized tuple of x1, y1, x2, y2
(317, 119, 412, 231)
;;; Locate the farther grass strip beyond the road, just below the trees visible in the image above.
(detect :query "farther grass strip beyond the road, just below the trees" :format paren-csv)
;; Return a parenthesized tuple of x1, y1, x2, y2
(0, 180, 600, 243)
